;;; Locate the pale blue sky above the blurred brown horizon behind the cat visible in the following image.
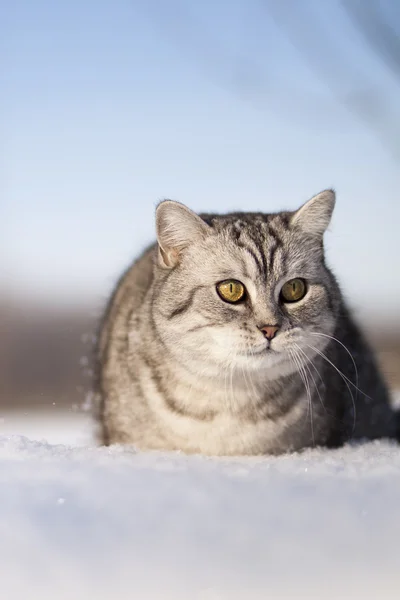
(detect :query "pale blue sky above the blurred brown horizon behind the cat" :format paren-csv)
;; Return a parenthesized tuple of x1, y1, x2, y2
(0, 0, 400, 322)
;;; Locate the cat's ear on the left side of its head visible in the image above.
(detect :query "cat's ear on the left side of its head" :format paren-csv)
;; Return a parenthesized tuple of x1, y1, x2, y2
(156, 200, 210, 268)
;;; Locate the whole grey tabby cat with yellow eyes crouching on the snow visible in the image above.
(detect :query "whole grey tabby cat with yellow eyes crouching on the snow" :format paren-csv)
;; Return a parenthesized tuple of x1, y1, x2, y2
(97, 190, 396, 455)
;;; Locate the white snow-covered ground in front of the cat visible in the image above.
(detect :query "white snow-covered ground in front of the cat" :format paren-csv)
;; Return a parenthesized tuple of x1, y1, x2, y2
(0, 398, 400, 600)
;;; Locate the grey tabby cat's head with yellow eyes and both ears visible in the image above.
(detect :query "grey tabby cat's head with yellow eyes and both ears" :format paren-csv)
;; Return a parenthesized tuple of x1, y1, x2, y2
(153, 190, 340, 377)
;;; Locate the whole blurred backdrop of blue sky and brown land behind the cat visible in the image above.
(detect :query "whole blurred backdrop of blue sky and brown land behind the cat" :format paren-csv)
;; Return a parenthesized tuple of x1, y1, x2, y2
(0, 0, 400, 443)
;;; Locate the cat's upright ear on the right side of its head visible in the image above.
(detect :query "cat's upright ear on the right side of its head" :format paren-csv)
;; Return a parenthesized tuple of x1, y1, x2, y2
(290, 190, 335, 237)
